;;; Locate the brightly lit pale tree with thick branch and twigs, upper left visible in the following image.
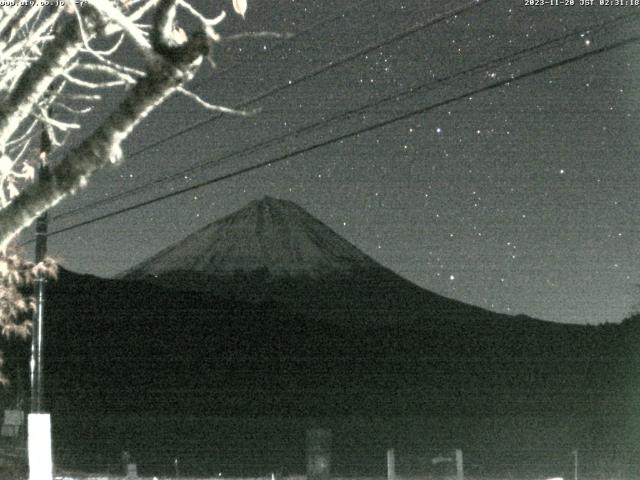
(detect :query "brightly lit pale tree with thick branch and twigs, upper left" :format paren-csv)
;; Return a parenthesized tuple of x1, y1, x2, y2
(0, 0, 248, 372)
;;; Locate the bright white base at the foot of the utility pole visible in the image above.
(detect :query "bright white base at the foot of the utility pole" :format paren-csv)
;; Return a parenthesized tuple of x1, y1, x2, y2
(27, 413, 53, 480)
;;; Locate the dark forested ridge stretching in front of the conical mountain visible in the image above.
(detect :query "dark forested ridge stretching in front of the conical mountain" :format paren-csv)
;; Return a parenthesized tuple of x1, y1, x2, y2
(6, 270, 640, 422)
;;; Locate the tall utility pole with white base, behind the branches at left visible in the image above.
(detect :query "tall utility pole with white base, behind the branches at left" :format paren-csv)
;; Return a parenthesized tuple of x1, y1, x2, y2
(27, 122, 53, 480)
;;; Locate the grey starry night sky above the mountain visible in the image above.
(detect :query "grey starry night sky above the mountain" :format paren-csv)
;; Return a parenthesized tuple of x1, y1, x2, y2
(23, 0, 640, 323)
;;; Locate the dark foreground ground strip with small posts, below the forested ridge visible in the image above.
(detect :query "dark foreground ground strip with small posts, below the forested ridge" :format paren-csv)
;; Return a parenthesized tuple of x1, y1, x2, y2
(4, 415, 628, 480)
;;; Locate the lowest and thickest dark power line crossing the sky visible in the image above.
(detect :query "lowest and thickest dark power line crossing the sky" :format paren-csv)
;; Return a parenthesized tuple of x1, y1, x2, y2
(28, 31, 640, 245)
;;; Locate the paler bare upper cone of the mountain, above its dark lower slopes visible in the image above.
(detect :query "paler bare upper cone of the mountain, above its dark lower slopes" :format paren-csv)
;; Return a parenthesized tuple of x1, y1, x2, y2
(124, 197, 380, 278)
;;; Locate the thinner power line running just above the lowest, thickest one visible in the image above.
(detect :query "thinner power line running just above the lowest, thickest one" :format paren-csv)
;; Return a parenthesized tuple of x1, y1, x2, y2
(53, 7, 640, 220)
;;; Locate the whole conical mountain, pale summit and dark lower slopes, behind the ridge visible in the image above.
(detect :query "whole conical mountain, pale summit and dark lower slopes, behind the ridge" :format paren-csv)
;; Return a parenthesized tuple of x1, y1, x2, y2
(120, 197, 510, 328)
